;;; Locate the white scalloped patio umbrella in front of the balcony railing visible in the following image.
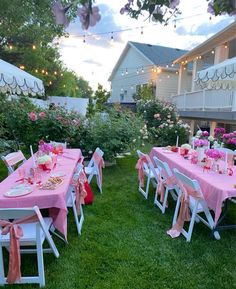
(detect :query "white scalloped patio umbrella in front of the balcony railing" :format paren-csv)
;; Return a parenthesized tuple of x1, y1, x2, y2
(195, 57, 236, 89)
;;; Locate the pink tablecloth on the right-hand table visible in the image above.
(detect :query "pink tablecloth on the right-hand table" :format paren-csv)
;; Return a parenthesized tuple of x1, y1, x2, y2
(150, 147, 236, 224)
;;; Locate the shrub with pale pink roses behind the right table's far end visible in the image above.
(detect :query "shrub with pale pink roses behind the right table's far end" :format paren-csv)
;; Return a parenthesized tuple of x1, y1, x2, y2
(137, 100, 190, 146)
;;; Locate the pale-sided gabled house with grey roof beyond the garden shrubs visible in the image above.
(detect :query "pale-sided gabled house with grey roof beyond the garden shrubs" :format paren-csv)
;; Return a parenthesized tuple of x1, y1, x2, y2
(108, 41, 191, 103)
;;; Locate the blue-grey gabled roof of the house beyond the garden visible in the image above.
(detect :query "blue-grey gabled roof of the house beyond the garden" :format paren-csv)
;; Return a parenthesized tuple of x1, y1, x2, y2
(108, 41, 188, 81)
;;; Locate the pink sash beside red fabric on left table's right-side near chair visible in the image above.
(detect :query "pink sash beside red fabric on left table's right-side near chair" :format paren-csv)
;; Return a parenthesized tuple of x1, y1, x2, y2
(72, 171, 88, 215)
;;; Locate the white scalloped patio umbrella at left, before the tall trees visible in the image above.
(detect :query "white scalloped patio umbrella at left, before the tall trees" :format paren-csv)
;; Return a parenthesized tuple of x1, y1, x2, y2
(0, 59, 44, 96)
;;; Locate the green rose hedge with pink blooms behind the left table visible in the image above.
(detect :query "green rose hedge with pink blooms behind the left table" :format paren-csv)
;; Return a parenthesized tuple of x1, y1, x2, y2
(0, 97, 83, 148)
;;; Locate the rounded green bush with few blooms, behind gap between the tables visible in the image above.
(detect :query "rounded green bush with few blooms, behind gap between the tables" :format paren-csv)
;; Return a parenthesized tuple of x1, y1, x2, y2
(81, 109, 143, 160)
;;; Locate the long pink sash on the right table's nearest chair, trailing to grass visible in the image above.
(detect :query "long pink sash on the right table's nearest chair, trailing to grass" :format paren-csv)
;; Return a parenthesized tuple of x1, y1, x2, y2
(167, 181, 203, 238)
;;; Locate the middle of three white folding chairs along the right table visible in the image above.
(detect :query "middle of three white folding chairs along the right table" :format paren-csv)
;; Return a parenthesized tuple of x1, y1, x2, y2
(153, 156, 178, 214)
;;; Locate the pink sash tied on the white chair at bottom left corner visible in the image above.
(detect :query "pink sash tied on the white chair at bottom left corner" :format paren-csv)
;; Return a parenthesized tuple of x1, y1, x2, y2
(0, 215, 38, 284)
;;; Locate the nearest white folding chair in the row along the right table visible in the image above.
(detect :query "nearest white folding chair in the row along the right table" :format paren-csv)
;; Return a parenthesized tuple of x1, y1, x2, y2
(172, 169, 220, 242)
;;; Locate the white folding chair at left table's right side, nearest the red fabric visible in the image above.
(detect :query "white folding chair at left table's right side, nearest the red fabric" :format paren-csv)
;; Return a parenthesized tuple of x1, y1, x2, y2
(66, 164, 84, 235)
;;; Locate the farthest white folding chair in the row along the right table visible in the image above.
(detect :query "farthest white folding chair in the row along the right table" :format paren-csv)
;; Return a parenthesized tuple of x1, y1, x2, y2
(137, 150, 159, 199)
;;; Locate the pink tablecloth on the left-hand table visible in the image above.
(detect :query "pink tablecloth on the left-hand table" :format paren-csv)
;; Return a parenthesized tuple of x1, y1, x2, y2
(0, 149, 82, 237)
